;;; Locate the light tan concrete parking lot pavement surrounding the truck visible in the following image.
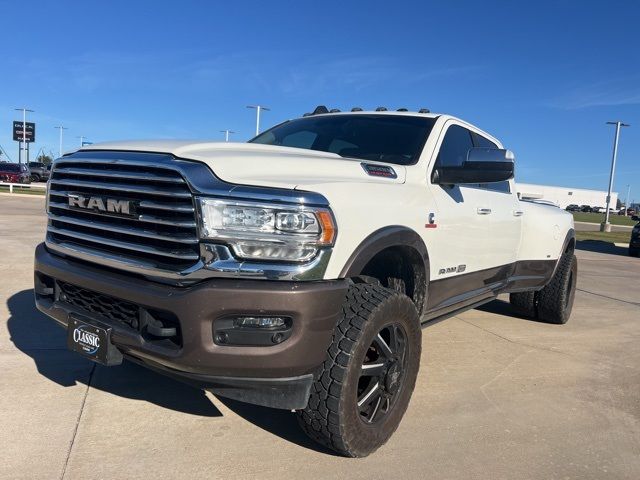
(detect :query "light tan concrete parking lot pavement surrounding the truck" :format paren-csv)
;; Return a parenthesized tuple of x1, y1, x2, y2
(0, 195, 640, 479)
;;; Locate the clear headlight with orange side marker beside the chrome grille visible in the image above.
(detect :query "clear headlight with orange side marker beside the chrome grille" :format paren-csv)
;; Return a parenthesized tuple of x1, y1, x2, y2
(198, 198, 336, 262)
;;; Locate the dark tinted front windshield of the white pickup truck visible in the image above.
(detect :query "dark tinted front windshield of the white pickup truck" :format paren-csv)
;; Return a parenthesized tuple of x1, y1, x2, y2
(250, 114, 435, 165)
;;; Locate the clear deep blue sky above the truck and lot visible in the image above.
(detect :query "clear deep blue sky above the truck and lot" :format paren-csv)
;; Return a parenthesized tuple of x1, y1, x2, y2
(0, 0, 640, 201)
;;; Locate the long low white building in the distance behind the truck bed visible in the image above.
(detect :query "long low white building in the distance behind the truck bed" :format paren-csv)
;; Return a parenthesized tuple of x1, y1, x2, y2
(516, 183, 618, 208)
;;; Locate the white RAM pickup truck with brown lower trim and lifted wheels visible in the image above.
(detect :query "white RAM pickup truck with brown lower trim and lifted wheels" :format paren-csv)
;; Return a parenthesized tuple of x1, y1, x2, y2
(35, 107, 577, 456)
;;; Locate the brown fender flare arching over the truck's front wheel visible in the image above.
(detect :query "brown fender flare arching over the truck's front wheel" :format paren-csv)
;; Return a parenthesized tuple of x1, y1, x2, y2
(339, 225, 430, 313)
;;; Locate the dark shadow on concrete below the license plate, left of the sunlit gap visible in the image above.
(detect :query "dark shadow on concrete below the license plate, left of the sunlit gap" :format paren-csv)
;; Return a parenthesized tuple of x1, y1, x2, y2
(7, 290, 222, 417)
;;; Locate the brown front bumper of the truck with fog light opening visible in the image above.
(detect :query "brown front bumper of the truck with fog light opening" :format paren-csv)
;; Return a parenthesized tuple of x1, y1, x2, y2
(35, 244, 348, 409)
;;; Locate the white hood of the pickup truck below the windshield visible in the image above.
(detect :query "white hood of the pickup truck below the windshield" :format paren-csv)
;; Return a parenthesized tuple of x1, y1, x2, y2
(81, 140, 406, 190)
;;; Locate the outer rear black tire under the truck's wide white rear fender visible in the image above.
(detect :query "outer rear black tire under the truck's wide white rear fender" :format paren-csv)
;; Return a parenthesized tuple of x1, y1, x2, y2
(536, 252, 578, 324)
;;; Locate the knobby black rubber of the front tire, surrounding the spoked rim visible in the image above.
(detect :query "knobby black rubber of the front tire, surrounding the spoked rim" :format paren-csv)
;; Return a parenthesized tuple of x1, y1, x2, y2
(297, 283, 422, 457)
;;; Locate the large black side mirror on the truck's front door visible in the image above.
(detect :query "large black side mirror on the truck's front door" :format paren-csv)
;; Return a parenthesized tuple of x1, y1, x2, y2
(433, 148, 514, 185)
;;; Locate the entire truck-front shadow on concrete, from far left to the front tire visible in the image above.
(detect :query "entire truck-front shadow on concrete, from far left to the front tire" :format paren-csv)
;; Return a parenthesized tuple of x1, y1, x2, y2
(7, 290, 335, 455)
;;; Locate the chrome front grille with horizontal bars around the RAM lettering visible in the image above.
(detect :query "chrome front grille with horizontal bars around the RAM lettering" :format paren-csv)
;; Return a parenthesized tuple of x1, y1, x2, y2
(47, 156, 200, 272)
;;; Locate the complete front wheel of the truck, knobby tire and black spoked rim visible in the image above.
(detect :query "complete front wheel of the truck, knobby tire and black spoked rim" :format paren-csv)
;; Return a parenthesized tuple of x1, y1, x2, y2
(297, 283, 422, 457)
